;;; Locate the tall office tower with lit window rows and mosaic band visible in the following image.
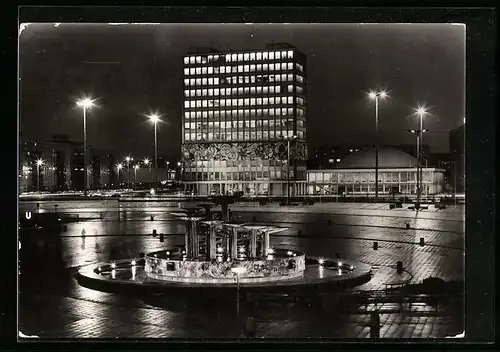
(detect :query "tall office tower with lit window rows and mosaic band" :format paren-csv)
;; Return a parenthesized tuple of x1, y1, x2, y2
(182, 44, 307, 196)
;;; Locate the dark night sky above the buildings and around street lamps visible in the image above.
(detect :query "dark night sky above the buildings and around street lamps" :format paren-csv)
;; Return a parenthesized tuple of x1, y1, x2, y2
(19, 24, 465, 156)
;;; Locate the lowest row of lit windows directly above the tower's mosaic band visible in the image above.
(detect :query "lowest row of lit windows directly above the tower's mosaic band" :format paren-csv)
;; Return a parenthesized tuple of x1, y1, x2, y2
(184, 127, 304, 142)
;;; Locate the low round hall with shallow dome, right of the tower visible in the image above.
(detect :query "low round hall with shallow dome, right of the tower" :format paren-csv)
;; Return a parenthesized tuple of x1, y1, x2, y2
(307, 147, 444, 195)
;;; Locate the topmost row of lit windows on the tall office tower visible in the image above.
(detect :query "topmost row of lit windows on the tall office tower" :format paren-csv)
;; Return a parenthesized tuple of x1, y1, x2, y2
(184, 50, 293, 65)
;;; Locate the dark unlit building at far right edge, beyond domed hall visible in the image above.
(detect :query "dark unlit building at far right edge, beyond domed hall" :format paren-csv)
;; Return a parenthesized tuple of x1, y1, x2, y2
(449, 124, 466, 193)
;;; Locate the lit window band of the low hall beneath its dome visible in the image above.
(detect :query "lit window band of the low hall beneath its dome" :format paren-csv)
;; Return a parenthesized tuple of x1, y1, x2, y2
(307, 171, 433, 183)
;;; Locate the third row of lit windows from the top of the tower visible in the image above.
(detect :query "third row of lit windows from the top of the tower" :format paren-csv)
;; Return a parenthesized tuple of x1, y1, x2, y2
(184, 73, 304, 86)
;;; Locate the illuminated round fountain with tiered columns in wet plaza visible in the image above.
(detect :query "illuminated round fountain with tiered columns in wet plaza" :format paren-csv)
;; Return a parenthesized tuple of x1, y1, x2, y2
(77, 199, 371, 290)
